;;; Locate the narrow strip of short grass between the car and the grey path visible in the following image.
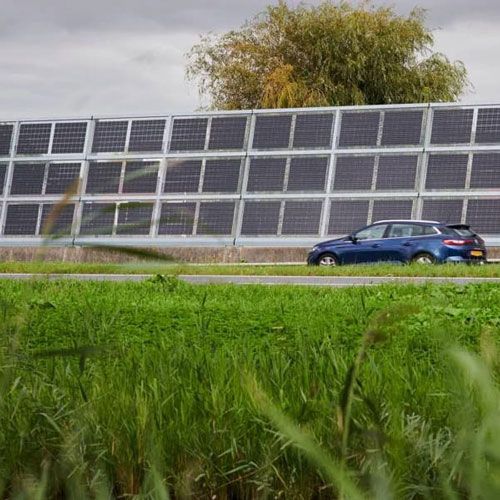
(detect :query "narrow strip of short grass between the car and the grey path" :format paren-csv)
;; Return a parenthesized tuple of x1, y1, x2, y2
(0, 261, 500, 278)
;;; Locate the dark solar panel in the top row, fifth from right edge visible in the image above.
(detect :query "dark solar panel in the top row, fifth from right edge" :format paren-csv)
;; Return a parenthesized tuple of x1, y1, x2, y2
(293, 113, 334, 148)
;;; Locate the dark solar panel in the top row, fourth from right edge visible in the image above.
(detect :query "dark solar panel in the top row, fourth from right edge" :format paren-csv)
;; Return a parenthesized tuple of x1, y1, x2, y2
(339, 111, 380, 148)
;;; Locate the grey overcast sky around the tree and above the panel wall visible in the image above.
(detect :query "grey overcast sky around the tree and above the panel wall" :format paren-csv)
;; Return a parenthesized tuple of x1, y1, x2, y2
(0, 0, 500, 120)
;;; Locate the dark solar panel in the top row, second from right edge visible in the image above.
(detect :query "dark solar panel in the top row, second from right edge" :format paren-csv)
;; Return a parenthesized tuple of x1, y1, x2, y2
(431, 109, 474, 144)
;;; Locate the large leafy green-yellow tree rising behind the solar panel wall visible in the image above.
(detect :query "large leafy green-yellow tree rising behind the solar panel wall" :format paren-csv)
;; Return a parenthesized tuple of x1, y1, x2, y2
(186, 0, 469, 109)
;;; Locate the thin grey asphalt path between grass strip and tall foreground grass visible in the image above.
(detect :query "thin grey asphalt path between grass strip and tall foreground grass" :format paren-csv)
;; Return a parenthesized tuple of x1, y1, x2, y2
(0, 273, 500, 287)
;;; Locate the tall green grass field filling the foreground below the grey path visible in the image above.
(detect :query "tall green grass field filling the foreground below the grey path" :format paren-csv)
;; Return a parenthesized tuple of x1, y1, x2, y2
(0, 277, 500, 499)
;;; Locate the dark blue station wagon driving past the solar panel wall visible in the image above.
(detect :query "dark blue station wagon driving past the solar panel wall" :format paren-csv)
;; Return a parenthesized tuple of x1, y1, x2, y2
(307, 220, 487, 266)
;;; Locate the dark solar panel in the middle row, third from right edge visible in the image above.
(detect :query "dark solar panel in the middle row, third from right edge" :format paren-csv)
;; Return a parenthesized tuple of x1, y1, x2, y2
(377, 155, 418, 191)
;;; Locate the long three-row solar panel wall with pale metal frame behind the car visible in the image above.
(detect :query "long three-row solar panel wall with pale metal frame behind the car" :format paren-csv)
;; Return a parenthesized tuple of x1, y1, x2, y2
(0, 105, 500, 241)
